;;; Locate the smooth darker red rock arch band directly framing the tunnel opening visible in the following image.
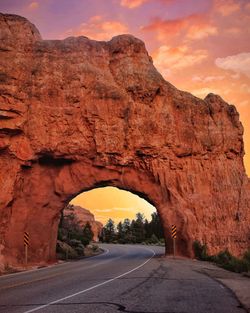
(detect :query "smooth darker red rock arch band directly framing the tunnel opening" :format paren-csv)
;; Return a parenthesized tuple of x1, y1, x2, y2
(2, 157, 192, 264)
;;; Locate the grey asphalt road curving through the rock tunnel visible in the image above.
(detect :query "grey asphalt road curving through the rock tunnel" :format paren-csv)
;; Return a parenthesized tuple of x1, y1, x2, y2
(0, 245, 245, 313)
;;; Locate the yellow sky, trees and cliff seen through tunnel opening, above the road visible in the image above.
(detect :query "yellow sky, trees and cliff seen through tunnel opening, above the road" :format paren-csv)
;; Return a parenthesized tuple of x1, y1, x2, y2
(56, 184, 165, 259)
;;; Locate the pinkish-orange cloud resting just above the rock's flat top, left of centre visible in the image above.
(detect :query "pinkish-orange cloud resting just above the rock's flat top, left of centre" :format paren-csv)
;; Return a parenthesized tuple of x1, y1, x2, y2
(62, 15, 128, 40)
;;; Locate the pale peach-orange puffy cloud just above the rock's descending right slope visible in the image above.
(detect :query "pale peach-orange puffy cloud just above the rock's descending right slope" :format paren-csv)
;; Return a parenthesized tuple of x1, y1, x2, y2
(153, 45, 208, 76)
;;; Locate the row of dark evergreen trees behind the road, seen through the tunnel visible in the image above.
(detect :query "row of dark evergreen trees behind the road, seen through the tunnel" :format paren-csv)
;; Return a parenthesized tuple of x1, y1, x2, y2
(100, 212, 164, 244)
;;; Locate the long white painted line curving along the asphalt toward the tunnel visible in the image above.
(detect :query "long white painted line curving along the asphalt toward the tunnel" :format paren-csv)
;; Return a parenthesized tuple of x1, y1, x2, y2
(23, 248, 155, 313)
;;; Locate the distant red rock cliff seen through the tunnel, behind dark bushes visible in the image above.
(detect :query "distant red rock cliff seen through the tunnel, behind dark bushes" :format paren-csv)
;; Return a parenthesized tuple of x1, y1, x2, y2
(63, 205, 103, 241)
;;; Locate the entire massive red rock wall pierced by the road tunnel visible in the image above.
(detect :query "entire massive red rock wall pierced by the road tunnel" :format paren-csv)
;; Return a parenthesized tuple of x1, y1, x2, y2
(0, 15, 250, 265)
